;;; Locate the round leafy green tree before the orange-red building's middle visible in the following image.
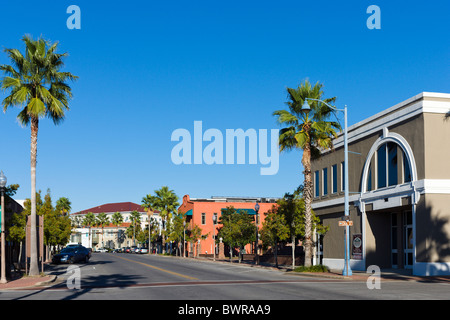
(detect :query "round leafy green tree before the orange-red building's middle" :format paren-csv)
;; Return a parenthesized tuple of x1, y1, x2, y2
(217, 206, 256, 262)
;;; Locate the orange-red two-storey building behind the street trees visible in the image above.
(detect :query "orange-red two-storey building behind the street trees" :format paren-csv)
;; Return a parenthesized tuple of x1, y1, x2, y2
(179, 195, 278, 255)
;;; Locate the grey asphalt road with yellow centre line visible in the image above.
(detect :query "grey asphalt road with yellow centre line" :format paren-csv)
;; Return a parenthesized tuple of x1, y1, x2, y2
(0, 253, 450, 302)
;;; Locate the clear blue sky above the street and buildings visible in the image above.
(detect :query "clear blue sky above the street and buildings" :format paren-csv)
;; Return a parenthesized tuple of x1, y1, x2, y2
(0, 0, 450, 212)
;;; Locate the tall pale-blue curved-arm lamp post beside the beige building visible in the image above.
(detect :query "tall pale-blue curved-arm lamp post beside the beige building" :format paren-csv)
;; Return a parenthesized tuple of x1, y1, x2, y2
(302, 98, 352, 276)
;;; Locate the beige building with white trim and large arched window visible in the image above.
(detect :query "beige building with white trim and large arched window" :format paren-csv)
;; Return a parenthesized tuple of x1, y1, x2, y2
(312, 92, 450, 275)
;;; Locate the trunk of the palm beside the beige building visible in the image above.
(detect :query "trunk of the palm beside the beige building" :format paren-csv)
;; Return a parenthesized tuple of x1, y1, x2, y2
(302, 144, 313, 267)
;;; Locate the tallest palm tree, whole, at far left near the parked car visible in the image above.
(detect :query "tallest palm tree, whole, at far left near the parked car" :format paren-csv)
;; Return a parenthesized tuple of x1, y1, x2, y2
(0, 35, 77, 276)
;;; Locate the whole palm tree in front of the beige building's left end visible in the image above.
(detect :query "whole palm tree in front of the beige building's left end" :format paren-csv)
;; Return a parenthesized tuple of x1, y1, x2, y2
(273, 80, 341, 266)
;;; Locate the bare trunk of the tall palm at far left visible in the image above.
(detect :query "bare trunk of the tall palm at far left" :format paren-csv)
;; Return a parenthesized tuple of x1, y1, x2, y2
(30, 117, 39, 276)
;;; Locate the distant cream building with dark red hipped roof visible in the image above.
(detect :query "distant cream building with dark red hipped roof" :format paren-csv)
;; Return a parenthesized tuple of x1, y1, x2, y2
(70, 202, 161, 249)
